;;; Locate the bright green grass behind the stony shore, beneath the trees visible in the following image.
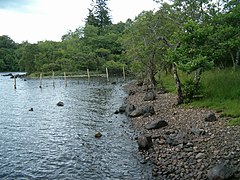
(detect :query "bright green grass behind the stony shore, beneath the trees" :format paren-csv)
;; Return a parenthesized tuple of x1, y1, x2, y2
(159, 69, 240, 125)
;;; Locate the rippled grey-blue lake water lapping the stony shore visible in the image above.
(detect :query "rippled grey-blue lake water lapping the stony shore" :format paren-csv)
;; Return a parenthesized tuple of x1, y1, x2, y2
(0, 73, 151, 180)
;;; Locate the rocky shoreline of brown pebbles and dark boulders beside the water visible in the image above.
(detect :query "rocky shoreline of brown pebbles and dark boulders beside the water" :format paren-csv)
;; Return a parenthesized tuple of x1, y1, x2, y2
(122, 83, 240, 180)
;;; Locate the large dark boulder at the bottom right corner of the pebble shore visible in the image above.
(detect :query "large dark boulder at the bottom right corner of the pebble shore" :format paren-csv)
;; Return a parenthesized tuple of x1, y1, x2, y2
(207, 164, 234, 180)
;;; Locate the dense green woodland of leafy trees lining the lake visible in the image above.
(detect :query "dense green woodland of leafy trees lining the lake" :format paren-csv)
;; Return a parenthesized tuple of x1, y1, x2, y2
(0, 0, 240, 103)
